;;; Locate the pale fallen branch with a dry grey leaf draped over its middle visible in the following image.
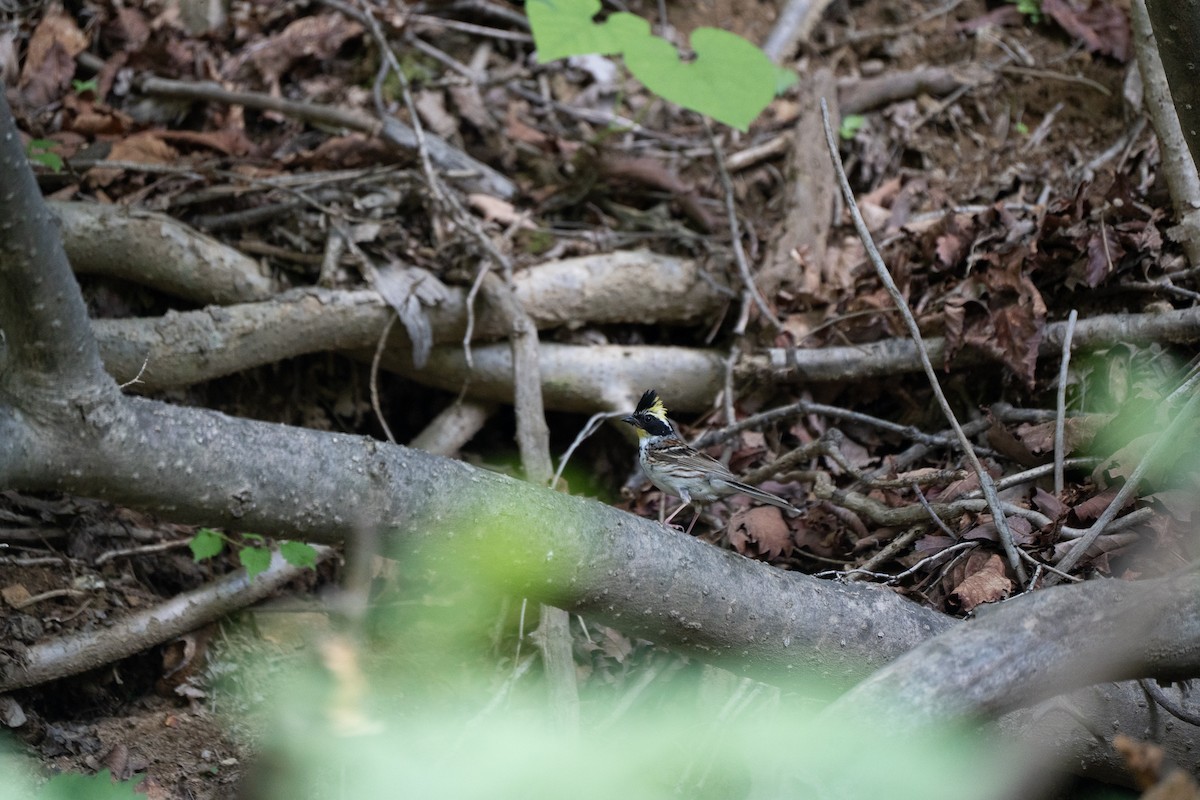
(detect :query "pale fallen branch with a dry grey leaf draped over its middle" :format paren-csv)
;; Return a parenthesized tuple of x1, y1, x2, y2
(94, 252, 725, 391)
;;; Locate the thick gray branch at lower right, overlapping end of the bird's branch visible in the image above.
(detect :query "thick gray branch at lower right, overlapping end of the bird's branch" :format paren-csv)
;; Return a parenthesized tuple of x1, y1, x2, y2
(830, 573, 1200, 727)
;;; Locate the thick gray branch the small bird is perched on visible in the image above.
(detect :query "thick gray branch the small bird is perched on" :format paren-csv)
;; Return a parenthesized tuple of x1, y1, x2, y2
(0, 398, 953, 686)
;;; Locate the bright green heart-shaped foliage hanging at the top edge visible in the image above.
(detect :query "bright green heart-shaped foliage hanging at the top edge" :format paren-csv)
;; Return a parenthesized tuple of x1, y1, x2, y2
(526, 0, 777, 131)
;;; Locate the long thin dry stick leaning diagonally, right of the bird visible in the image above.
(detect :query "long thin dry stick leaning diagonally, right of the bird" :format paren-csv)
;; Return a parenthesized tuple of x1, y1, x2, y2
(821, 98, 1028, 585)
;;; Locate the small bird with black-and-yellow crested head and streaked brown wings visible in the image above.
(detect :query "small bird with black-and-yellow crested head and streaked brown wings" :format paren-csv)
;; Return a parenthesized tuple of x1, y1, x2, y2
(622, 389, 798, 534)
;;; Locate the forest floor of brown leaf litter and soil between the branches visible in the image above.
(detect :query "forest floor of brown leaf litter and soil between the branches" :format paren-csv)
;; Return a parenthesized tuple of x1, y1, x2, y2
(0, 0, 1180, 798)
